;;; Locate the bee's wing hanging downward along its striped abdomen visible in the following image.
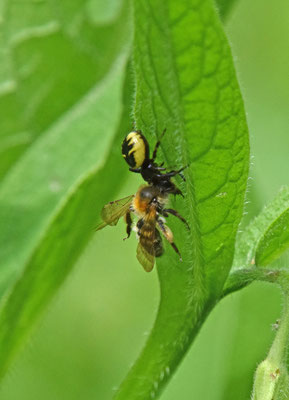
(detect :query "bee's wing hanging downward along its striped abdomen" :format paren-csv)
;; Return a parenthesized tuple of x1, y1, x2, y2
(136, 219, 159, 272)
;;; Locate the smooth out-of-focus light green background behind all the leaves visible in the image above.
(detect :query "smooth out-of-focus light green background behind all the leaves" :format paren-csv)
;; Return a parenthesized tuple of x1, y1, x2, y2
(0, 0, 289, 400)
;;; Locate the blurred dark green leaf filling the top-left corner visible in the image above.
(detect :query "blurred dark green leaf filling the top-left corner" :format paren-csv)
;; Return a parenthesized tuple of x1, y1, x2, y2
(0, 0, 127, 179)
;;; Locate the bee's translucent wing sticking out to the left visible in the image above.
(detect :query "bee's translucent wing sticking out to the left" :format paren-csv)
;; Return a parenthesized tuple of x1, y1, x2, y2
(95, 194, 134, 231)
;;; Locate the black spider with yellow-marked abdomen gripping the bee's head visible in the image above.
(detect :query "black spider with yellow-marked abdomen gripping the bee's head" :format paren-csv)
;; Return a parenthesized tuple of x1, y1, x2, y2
(122, 129, 187, 197)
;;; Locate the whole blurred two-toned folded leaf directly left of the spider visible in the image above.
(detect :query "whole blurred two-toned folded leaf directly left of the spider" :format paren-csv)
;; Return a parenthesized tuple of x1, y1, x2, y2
(0, 0, 132, 377)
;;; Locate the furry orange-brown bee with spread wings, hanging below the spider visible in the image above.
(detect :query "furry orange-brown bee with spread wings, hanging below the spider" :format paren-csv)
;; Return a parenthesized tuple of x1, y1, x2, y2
(96, 185, 189, 272)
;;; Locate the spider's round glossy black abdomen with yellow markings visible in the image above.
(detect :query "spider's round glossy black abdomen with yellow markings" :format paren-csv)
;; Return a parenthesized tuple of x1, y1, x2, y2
(122, 131, 149, 168)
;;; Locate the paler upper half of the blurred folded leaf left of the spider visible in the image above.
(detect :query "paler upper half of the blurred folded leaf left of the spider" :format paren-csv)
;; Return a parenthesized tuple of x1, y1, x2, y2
(0, 50, 126, 295)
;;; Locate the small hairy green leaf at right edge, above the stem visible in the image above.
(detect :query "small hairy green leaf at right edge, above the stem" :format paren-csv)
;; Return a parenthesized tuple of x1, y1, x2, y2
(223, 187, 289, 296)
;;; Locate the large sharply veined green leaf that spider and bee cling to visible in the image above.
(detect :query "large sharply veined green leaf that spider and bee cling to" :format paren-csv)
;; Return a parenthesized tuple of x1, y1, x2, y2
(115, 0, 249, 400)
